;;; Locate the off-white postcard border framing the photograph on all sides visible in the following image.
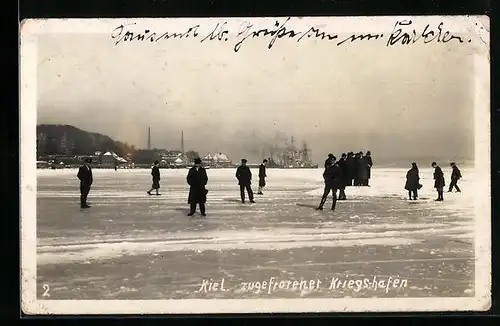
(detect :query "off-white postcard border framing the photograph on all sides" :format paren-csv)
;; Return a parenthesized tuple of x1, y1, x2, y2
(20, 16, 491, 314)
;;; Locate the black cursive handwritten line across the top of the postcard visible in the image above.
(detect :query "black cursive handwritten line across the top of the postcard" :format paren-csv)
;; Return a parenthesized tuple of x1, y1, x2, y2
(111, 17, 470, 52)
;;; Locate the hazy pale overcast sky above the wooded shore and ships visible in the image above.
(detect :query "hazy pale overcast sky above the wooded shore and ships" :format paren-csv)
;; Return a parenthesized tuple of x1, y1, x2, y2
(38, 18, 474, 162)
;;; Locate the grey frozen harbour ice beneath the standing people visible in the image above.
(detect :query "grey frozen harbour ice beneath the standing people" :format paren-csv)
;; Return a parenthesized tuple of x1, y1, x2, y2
(37, 168, 474, 299)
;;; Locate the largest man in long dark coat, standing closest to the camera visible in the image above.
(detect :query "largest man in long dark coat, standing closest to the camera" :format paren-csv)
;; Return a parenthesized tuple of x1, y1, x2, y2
(186, 158, 208, 216)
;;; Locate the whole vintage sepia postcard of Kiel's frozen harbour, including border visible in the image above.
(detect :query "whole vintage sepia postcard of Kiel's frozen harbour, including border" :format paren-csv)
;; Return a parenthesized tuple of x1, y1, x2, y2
(20, 16, 491, 314)
